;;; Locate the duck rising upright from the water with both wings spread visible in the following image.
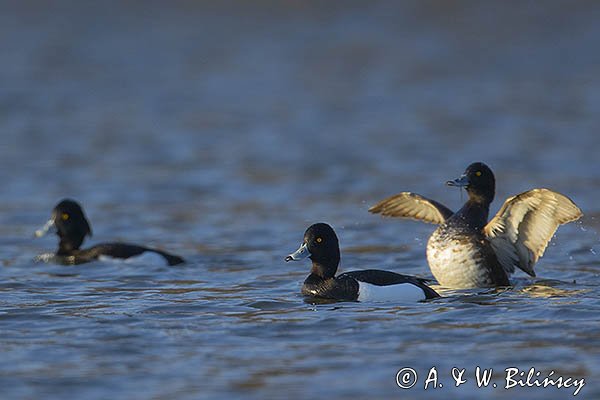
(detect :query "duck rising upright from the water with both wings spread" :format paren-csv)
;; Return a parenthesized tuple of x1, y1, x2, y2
(369, 162, 583, 289)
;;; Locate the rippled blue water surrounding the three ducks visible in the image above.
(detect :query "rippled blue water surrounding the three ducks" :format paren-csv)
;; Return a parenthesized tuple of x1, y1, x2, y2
(0, 1, 600, 399)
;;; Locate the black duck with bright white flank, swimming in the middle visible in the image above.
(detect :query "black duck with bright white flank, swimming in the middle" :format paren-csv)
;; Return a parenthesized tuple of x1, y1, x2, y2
(285, 222, 440, 302)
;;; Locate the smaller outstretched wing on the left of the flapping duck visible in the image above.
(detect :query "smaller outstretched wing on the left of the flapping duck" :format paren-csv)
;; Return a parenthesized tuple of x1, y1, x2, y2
(369, 192, 454, 224)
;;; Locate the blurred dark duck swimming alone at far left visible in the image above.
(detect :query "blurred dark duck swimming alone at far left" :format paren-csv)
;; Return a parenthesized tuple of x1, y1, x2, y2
(35, 199, 185, 265)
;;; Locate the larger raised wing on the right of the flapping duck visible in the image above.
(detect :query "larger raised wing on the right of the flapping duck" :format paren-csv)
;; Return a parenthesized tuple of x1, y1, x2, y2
(483, 189, 583, 276)
